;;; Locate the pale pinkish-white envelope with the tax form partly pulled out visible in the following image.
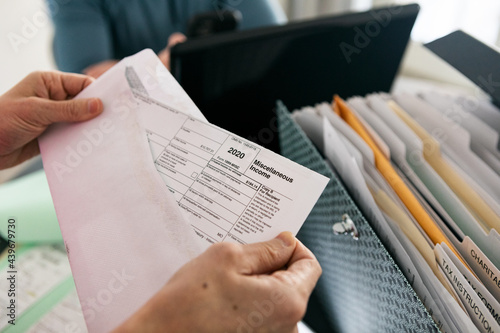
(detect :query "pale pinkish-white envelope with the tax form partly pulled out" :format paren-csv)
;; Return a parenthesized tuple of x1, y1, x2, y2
(40, 51, 201, 332)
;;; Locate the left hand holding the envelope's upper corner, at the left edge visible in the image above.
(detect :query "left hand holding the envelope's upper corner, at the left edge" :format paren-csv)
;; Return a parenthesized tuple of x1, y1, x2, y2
(0, 72, 102, 169)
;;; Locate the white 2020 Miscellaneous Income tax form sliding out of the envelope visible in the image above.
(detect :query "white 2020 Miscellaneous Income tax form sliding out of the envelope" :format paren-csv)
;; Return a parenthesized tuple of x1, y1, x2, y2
(125, 67, 328, 246)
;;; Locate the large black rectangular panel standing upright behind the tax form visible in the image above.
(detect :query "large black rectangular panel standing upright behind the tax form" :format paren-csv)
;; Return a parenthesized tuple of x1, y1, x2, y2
(171, 4, 419, 151)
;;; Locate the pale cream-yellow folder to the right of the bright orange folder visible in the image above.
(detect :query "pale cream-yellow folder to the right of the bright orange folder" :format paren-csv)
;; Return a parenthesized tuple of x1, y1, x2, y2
(388, 101, 500, 233)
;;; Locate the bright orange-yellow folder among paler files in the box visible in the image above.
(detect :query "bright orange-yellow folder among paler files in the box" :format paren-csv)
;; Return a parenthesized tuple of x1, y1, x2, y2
(334, 95, 461, 258)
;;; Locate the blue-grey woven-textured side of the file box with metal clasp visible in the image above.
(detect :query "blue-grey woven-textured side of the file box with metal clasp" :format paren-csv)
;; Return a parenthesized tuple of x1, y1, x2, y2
(276, 102, 439, 332)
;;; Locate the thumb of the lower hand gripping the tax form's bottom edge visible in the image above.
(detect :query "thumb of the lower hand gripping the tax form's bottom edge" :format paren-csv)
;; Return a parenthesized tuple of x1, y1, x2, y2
(241, 231, 297, 275)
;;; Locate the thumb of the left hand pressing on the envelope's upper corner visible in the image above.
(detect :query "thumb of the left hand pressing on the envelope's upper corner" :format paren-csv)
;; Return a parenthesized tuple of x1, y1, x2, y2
(36, 98, 103, 126)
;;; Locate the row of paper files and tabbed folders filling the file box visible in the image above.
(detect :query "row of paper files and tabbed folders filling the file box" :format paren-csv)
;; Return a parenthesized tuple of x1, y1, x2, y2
(293, 92, 500, 332)
